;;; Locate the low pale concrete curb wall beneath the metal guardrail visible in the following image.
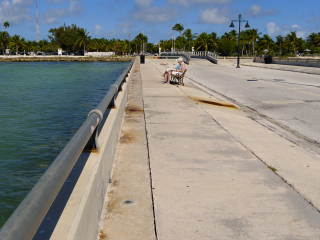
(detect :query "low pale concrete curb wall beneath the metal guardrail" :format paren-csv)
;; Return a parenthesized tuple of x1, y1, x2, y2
(50, 61, 138, 240)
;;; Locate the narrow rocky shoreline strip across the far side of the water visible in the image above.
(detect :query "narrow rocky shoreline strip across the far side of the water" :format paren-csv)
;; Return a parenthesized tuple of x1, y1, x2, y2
(0, 56, 134, 62)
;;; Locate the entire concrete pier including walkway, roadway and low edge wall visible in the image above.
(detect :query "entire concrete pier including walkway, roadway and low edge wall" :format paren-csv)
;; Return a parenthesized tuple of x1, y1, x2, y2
(0, 58, 320, 240)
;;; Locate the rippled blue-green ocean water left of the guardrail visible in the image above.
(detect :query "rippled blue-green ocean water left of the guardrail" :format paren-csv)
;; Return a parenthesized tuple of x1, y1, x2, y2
(0, 62, 129, 227)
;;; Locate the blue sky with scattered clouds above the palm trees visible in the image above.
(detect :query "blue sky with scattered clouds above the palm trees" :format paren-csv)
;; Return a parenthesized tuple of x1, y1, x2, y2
(0, 0, 320, 43)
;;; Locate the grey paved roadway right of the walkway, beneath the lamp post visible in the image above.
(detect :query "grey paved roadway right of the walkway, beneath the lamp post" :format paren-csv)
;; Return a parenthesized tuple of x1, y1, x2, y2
(188, 59, 320, 152)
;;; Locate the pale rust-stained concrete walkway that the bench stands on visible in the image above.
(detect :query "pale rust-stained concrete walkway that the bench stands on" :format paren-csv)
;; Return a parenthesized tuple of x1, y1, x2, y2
(98, 60, 320, 240)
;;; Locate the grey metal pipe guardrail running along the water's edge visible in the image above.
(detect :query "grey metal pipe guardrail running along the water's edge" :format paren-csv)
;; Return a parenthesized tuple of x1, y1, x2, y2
(0, 59, 135, 240)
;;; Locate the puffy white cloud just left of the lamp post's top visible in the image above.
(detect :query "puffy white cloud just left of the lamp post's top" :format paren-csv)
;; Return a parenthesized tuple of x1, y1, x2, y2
(199, 8, 230, 24)
